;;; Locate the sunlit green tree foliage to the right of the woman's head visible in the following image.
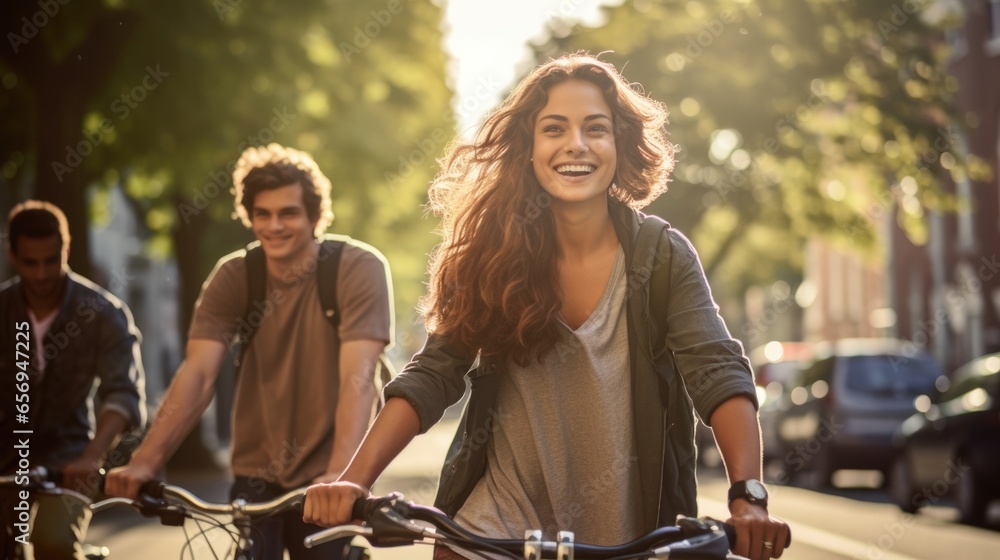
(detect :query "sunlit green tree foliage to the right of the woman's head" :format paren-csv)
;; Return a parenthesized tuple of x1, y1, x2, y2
(535, 0, 980, 293)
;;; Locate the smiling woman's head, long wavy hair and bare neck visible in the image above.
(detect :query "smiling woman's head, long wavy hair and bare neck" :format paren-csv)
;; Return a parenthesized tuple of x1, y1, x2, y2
(424, 56, 674, 365)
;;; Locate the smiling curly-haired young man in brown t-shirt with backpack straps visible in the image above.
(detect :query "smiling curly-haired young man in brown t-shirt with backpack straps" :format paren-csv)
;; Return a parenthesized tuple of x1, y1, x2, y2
(107, 144, 392, 560)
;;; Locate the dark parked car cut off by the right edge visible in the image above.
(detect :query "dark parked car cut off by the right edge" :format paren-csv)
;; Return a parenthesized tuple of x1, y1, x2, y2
(891, 353, 1000, 524)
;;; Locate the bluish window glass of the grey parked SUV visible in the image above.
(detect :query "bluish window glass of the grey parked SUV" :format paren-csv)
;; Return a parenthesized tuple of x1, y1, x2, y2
(847, 355, 940, 397)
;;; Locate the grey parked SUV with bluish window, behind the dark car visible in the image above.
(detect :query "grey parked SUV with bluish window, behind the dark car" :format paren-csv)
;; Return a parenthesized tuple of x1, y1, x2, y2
(777, 339, 941, 488)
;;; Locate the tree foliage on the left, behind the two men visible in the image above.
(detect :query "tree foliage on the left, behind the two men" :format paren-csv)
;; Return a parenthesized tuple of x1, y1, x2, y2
(0, 0, 454, 340)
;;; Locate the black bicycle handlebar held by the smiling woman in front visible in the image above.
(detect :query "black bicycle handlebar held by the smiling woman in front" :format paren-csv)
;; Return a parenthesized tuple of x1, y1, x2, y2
(305, 493, 736, 560)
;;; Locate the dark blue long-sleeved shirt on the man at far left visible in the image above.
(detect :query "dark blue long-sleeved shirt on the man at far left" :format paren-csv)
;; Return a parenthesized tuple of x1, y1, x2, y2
(0, 272, 146, 472)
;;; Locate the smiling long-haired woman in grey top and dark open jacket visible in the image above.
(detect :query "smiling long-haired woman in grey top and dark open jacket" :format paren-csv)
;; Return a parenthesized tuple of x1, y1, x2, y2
(304, 54, 788, 560)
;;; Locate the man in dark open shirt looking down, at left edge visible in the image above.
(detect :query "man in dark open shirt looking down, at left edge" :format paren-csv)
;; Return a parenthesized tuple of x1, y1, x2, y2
(0, 200, 146, 560)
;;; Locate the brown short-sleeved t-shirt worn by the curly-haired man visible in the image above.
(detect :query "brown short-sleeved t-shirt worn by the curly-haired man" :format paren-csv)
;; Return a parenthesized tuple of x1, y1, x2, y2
(189, 240, 392, 488)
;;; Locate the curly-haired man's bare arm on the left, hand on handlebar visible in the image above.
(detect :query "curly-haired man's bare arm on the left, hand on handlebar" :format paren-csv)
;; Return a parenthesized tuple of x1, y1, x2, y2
(105, 339, 226, 499)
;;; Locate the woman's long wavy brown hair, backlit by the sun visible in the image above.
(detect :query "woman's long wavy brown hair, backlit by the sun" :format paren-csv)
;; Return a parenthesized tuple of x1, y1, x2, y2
(421, 53, 675, 366)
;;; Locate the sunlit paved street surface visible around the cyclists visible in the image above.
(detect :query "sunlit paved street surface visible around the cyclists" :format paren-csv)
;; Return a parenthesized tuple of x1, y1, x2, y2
(88, 420, 1000, 560)
